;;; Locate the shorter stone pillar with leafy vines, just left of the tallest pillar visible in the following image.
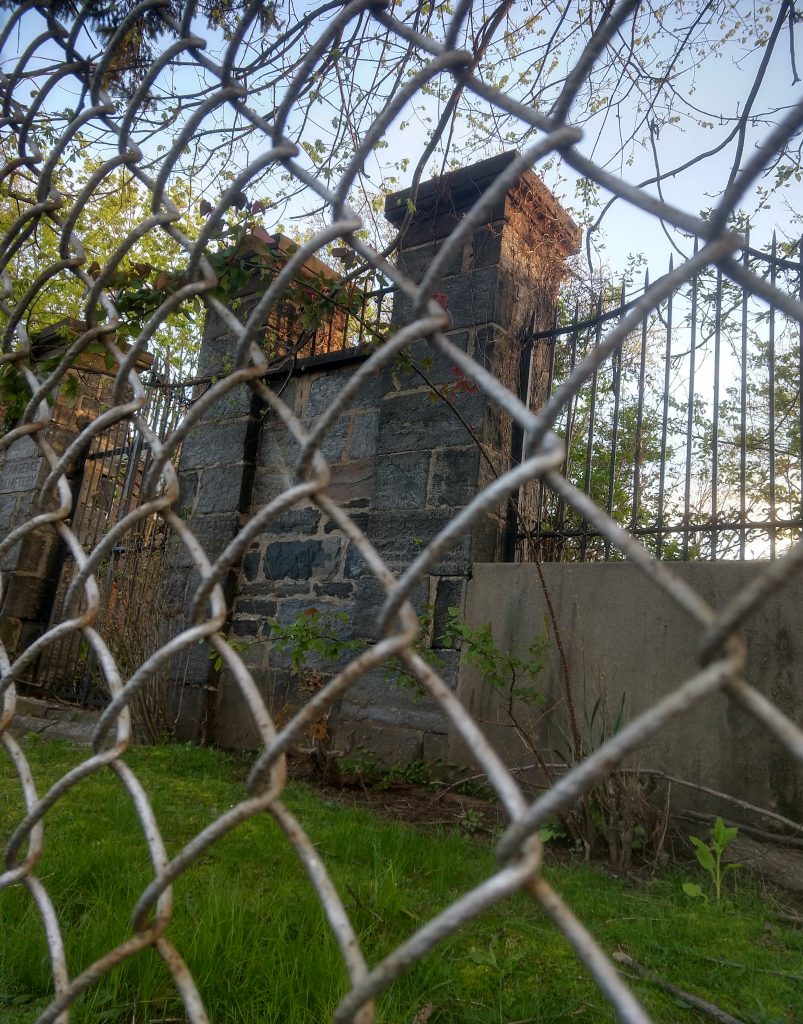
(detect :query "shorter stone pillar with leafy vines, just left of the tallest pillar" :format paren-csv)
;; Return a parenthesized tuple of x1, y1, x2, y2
(162, 236, 348, 745)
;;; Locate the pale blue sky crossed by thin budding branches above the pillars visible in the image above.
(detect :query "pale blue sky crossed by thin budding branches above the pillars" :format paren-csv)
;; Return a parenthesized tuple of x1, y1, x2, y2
(3, 0, 801, 256)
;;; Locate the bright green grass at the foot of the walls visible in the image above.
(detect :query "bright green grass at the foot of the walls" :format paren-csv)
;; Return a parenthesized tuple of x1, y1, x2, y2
(0, 739, 803, 1024)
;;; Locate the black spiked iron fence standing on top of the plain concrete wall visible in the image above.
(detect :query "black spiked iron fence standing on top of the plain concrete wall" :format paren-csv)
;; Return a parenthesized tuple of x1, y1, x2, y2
(531, 237, 803, 561)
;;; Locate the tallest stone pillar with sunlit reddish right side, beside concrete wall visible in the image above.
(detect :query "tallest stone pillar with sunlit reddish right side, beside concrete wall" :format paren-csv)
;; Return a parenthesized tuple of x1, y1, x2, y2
(375, 153, 581, 634)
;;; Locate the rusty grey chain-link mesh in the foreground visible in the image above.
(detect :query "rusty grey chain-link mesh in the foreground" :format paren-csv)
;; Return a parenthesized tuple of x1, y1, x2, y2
(0, 0, 803, 1024)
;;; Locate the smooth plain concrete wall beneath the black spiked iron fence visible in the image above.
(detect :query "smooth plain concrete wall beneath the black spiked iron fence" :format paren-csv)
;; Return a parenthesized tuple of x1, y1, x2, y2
(458, 562, 803, 819)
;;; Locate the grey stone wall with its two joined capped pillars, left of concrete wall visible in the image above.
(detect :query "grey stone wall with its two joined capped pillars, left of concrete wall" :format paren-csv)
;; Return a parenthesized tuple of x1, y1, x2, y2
(171, 154, 579, 762)
